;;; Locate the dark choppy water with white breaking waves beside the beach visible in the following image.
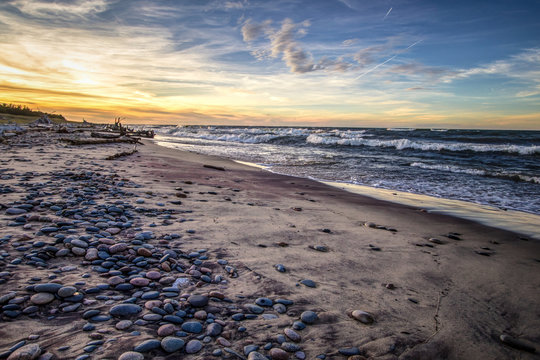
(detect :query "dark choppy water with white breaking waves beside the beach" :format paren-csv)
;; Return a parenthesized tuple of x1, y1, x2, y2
(148, 126, 540, 214)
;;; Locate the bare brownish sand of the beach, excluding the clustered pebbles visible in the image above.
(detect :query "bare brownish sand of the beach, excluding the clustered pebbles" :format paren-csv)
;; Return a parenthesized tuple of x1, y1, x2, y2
(0, 133, 540, 359)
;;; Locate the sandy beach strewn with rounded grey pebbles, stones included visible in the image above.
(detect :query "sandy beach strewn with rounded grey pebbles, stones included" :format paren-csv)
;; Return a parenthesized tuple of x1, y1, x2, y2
(0, 131, 540, 360)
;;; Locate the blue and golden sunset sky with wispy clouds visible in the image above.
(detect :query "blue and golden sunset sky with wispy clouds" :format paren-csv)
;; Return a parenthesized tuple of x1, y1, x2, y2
(0, 0, 540, 130)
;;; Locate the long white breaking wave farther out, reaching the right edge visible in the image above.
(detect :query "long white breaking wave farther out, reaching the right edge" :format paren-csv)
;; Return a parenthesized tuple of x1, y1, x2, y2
(306, 134, 540, 155)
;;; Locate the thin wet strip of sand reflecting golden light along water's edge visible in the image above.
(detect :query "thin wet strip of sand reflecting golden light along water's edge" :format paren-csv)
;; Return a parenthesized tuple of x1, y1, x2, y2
(153, 140, 540, 240)
